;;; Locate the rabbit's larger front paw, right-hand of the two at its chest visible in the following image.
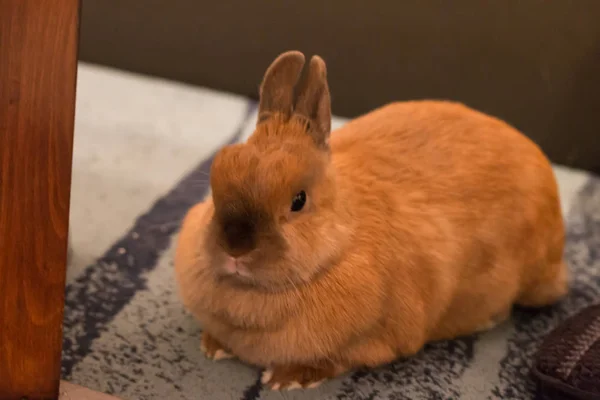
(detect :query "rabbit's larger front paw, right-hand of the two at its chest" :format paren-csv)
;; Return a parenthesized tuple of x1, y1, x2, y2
(261, 362, 341, 390)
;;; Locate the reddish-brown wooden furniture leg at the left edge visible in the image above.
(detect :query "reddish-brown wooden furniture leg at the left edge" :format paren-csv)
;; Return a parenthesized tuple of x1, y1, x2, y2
(0, 0, 79, 400)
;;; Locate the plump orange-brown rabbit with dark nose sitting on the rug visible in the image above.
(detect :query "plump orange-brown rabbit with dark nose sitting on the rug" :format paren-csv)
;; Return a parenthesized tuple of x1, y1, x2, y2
(175, 51, 569, 390)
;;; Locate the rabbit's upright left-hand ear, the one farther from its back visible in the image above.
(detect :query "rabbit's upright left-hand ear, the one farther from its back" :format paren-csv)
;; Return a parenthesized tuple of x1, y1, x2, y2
(258, 51, 305, 122)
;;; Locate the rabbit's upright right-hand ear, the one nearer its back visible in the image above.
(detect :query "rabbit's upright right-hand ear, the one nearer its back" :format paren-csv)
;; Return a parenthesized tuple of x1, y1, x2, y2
(294, 56, 331, 147)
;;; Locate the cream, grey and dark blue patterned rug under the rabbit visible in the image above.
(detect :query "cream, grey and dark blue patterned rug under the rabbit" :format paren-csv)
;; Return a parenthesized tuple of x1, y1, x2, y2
(63, 64, 600, 400)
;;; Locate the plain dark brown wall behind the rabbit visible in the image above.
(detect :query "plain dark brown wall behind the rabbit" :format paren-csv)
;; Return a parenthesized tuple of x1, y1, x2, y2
(80, 0, 600, 171)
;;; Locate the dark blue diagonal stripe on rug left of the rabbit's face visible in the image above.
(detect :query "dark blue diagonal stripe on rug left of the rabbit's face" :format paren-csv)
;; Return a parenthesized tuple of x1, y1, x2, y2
(62, 102, 256, 379)
